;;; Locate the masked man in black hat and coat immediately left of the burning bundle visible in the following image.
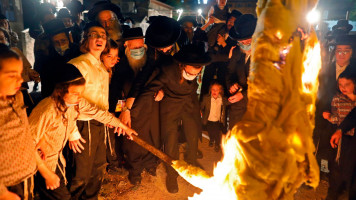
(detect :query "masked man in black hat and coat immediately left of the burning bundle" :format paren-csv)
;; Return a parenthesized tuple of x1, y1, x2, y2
(226, 14, 257, 130)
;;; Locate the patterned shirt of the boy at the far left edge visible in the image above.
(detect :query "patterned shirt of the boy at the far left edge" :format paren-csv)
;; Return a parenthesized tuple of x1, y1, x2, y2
(0, 92, 36, 195)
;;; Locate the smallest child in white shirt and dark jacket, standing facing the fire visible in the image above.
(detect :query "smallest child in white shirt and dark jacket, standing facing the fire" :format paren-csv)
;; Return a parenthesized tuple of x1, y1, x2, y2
(200, 81, 229, 152)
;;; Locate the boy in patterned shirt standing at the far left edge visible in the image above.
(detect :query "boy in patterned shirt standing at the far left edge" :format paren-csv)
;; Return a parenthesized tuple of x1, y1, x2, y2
(0, 44, 36, 200)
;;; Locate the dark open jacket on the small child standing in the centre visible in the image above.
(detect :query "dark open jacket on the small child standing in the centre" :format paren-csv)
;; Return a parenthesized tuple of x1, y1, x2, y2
(200, 94, 230, 125)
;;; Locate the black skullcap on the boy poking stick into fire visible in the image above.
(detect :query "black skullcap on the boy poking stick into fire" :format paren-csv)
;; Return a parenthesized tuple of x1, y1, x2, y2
(55, 63, 83, 84)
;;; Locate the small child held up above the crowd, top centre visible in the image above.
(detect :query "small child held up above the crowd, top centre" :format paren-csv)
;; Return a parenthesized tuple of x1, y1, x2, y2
(203, 0, 230, 47)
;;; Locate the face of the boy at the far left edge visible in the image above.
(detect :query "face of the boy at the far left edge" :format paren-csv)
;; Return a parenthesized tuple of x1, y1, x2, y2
(0, 58, 23, 97)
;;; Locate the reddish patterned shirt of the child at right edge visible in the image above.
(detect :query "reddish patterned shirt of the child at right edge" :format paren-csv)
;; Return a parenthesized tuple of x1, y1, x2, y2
(330, 93, 356, 136)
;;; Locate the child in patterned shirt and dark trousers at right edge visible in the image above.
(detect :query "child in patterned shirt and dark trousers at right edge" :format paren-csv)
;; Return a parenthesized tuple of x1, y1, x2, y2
(323, 69, 356, 199)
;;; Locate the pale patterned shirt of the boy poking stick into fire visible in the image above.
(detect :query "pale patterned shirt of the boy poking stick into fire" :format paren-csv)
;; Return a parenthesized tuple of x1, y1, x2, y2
(29, 97, 120, 172)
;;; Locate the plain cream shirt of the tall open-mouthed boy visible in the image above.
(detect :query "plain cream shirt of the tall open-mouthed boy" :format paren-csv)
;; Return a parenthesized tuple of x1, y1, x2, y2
(68, 53, 109, 121)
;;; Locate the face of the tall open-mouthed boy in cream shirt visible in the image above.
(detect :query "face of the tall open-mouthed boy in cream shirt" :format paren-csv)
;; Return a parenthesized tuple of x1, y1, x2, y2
(88, 26, 107, 52)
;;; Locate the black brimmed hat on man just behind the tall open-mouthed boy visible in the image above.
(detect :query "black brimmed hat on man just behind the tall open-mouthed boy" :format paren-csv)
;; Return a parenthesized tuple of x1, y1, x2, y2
(88, 1, 123, 21)
